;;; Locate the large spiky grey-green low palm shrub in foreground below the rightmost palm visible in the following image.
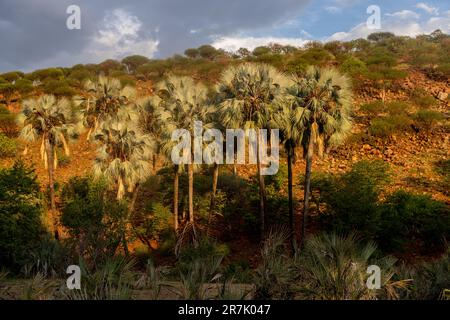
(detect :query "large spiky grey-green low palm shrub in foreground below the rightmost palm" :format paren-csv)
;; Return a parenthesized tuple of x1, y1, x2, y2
(298, 233, 409, 300)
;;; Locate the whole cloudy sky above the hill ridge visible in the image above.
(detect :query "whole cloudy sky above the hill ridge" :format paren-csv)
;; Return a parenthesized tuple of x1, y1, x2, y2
(0, 0, 450, 72)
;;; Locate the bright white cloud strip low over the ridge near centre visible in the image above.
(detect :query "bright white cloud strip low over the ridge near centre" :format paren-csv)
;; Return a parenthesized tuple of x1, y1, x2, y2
(212, 36, 308, 52)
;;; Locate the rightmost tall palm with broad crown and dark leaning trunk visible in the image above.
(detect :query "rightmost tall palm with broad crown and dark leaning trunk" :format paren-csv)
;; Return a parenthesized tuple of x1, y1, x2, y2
(288, 67, 352, 246)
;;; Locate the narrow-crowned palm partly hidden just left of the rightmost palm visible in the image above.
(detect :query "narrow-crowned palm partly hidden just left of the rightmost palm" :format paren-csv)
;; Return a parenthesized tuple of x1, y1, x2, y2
(271, 97, 305, 250)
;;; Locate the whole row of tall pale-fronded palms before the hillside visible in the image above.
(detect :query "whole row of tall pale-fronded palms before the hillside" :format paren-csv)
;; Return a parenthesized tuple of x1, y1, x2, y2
(17, 63, 352, 245)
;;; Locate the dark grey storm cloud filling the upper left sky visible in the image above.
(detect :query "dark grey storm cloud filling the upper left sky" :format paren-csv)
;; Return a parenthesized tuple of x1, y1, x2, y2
(0, 0, 307, 71)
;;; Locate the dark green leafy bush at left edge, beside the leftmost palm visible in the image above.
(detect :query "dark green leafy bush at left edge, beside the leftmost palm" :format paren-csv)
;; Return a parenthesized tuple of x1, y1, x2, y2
(0, 161, 46, 272)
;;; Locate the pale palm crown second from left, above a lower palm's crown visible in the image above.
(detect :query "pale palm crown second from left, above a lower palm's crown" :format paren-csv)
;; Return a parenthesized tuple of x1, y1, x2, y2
(74, 76, 136, 140)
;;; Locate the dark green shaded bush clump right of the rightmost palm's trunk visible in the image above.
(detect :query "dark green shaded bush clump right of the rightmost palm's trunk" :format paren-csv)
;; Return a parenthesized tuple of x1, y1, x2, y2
(312, 161, 450, 252)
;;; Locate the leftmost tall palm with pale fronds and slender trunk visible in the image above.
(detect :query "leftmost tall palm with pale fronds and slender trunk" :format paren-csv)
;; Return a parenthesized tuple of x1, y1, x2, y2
(18, 95, 79, 238)
